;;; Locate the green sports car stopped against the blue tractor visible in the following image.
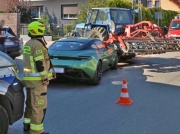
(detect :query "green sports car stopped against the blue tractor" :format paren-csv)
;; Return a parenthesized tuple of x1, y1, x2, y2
(48, 37, 118, 85)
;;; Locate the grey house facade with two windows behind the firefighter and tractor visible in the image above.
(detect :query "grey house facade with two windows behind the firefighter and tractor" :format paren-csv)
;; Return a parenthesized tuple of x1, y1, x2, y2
(31, 0, 88, 27)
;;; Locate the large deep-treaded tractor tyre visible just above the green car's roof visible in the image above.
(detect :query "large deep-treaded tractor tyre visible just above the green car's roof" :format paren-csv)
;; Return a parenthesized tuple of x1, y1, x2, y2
(88, 27, 109, 41)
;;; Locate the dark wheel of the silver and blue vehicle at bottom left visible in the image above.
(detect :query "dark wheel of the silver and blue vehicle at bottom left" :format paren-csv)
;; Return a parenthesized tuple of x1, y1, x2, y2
(0, 105, 9, 134)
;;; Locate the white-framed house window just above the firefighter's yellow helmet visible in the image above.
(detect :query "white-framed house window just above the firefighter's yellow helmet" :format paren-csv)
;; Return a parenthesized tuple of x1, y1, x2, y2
(31, 6, 43, 19)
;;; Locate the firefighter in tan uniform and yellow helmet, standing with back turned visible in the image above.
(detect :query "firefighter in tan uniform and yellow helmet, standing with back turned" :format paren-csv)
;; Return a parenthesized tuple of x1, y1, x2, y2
(23, 21, 55, 134)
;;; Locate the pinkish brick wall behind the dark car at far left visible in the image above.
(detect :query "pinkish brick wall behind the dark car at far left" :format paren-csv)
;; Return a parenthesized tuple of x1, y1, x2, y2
(0, 13, 20, 37)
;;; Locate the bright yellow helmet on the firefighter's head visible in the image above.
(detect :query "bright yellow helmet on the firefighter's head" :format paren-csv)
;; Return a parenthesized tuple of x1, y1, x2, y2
(27, 21, 45, 37)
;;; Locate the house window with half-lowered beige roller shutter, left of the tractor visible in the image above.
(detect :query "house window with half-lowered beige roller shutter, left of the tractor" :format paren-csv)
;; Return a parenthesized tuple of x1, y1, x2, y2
(61, 4, 78, 19)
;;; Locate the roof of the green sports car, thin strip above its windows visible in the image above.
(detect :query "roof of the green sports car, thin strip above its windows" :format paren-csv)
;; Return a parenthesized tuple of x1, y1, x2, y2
(59, 37, 99, 43)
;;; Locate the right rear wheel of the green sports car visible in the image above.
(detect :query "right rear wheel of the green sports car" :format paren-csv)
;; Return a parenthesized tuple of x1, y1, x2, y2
(92, 62, 102, 85)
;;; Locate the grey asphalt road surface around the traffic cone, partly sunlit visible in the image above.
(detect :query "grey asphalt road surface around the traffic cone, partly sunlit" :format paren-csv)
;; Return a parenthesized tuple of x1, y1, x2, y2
(9, 52, 180, 134)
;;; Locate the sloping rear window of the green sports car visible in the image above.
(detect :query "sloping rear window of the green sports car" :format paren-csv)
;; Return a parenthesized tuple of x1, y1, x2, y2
(51, 41, 86, 51)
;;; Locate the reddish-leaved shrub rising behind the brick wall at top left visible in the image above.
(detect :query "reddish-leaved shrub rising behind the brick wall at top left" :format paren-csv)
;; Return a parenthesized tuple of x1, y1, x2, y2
(7, 0, 32, 23)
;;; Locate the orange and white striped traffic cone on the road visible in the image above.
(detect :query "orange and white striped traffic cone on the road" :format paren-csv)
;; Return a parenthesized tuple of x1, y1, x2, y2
(116, 80, 133, 105)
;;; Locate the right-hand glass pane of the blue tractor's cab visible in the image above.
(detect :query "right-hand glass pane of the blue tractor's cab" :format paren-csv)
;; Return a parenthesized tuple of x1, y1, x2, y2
(110, 9, 132, 24)
